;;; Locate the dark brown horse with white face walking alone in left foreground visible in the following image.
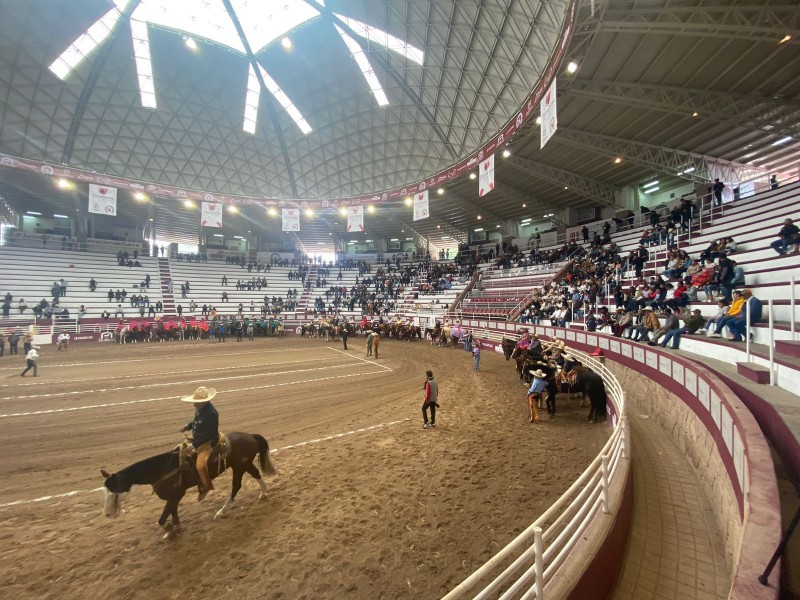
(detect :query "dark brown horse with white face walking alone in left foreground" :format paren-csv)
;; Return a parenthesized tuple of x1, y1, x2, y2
(100, 431, 276, 539)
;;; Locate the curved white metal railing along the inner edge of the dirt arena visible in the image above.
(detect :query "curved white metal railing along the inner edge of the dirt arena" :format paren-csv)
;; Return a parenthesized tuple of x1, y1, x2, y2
(444, 332, 630, 600)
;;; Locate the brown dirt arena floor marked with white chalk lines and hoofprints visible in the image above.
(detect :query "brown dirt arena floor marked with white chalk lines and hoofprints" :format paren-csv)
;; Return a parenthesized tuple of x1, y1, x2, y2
(0, 338, 609, 600)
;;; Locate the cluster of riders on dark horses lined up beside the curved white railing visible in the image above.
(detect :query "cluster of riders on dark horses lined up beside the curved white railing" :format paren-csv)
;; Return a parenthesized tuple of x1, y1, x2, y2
(501, 328, 606, 423)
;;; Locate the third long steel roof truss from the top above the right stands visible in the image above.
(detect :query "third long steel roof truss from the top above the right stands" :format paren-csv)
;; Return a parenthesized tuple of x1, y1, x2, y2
(554, 128, 769, 183)
